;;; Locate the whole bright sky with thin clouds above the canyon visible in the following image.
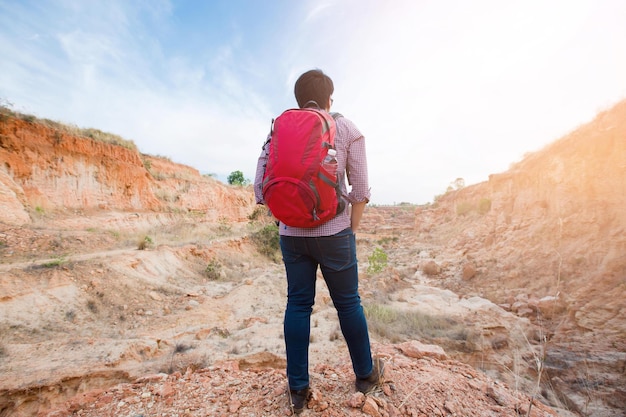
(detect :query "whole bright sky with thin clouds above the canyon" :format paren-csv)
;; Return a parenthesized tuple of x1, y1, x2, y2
(0, 0, 626, 204)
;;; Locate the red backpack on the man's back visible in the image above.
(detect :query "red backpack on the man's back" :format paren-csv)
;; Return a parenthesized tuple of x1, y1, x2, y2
(263, 108, 345, 228)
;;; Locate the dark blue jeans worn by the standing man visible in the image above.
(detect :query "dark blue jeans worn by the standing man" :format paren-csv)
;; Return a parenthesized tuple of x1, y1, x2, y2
(280, 228, 373, 390)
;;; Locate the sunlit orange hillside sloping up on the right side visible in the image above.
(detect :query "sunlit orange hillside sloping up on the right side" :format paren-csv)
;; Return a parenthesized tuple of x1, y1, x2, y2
(408, 101, 626, 415)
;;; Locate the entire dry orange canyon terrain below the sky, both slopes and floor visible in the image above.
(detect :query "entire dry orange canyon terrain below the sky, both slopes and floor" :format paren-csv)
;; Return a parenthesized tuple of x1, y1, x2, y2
(0, 102, 626, 416)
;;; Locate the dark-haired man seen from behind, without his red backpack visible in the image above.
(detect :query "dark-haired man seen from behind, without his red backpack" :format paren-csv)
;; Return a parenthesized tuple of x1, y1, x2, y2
(254, 69, 384, 413)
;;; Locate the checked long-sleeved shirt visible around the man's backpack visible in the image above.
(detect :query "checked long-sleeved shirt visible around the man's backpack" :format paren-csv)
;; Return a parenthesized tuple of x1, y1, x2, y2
(254, 112, 370, 237)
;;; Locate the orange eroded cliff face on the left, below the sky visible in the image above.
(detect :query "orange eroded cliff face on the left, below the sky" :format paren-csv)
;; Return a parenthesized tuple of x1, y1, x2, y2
(0, 115, 254, 225)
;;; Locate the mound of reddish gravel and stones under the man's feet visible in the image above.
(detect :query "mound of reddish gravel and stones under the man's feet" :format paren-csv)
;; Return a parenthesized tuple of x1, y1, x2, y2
(45, 343, 557, 417)
